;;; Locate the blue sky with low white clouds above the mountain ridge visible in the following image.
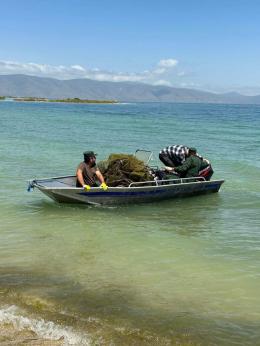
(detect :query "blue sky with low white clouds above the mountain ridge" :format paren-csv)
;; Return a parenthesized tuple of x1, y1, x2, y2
(0, 0, 260, 95)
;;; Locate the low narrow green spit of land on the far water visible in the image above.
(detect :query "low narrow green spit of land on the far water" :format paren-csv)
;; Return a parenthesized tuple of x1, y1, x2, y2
(0, 96, 119, 103)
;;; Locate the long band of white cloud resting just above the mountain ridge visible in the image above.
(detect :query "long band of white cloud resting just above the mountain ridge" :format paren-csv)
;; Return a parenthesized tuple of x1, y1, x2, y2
(0, 59, 260, 96)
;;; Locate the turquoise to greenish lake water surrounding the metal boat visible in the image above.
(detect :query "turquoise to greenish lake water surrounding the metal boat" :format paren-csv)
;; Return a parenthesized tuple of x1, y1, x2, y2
(0, 102, 260, 345)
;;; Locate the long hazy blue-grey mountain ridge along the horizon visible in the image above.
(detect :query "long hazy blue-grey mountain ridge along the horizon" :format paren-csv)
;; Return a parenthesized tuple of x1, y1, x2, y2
(0, 75, 260, 104)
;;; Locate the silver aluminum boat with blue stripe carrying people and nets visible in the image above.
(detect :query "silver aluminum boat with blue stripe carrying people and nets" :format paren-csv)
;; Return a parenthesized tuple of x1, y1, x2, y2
(28, 175, 224, 205)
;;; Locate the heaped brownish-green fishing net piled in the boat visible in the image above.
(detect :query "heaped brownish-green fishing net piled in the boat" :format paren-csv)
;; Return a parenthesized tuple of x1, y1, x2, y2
(98, 154, 153, 186)
